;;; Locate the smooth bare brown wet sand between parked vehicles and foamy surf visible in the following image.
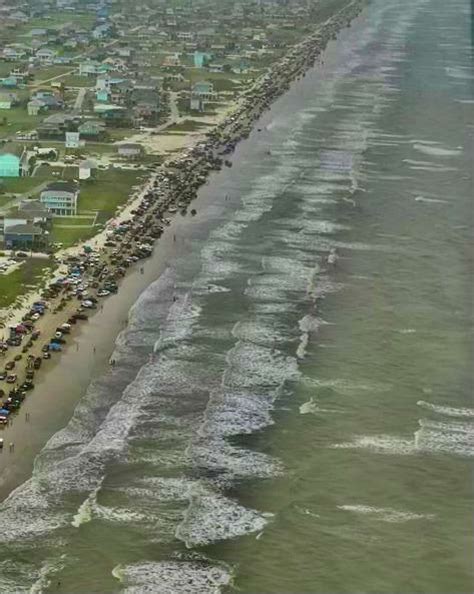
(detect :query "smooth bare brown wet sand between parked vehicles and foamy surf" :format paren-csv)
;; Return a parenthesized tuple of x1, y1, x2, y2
(0, 191, 219, 500)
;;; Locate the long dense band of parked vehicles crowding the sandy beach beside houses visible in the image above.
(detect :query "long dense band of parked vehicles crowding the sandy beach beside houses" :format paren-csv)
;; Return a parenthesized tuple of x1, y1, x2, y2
(0, 0, 361, 452)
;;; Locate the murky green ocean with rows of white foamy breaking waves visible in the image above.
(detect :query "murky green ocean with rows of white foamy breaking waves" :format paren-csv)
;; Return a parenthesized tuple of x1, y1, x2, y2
(0, 0, 474, 594)
